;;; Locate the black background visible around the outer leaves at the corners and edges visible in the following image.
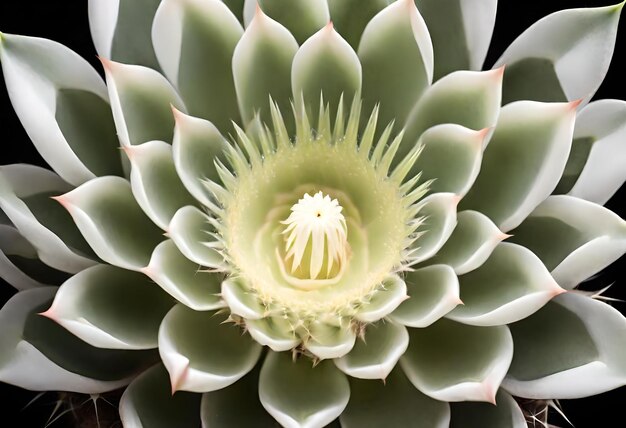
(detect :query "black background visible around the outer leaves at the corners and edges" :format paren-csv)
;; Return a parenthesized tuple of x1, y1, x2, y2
(0, 0, 626, 428)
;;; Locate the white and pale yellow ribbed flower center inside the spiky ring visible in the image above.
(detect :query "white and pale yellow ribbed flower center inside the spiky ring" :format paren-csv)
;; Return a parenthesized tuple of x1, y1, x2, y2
(281, 192, 348, 279)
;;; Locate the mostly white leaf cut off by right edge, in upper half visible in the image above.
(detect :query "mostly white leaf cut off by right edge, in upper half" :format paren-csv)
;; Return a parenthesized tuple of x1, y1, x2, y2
(555, 100, 626, 205)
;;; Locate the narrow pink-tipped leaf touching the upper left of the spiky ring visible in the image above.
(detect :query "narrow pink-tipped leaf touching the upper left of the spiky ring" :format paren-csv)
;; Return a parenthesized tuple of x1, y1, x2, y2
(172, 110, 228, 206)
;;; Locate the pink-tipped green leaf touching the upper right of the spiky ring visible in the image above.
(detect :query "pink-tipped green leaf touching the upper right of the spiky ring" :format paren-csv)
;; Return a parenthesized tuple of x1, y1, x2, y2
(407, 124, 489, 196)
